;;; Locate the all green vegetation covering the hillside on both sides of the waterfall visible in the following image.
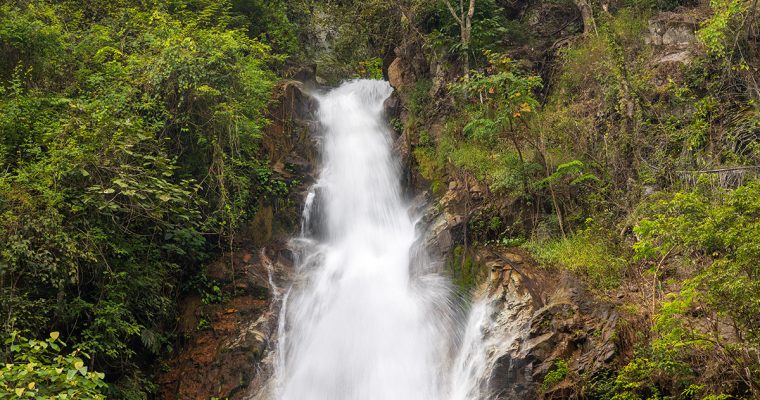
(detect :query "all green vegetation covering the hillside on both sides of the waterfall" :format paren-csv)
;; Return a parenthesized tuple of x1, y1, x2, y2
(0, 0, 760, 399)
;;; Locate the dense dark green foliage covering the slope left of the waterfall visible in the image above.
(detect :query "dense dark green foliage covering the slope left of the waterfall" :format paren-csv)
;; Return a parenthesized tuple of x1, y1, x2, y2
(0, 0, 296, 398)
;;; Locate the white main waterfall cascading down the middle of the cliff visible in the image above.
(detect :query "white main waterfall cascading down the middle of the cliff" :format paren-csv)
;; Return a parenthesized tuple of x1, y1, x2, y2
(275, 80, 484, 400)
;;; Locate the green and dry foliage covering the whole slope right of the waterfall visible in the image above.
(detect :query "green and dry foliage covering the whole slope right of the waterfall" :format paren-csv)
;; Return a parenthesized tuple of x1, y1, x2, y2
(394, 0, 760, 399)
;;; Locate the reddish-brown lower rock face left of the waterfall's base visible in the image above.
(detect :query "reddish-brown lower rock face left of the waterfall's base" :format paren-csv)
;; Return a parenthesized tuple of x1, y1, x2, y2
(160, 248, 290, 400)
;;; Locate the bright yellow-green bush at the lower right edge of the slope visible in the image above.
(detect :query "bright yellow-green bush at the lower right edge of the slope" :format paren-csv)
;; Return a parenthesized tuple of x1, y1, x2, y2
(617, 181, 760, 398)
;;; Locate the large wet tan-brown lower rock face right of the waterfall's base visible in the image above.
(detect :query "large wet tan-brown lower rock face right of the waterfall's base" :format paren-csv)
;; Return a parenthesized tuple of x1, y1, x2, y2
(479, 253, 618, 399)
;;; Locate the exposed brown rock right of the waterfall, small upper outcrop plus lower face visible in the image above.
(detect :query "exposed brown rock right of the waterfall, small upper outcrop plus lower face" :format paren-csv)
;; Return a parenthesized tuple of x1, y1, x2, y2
(422, 182, 619, 400)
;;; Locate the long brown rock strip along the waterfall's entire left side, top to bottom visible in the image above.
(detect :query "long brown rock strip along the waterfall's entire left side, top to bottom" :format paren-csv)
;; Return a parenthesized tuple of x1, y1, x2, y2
(159, 81, 317, 400)
